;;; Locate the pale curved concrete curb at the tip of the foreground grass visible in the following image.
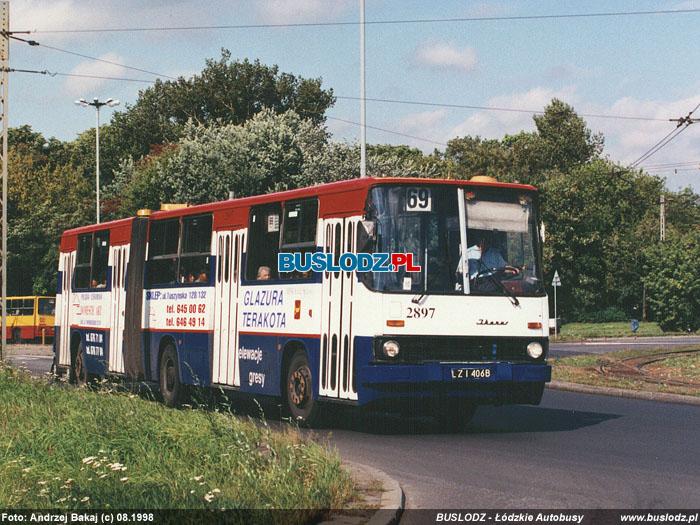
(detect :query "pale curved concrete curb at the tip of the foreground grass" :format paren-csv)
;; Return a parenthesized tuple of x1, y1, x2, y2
(322, 461, 406, 525)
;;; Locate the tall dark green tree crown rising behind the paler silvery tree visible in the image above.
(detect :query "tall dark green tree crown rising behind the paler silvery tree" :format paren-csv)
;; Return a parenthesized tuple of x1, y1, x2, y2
(111, 49, 335, 159)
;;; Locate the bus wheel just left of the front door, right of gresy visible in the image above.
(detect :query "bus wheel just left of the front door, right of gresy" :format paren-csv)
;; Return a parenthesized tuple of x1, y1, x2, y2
(285, 350, 319, 426)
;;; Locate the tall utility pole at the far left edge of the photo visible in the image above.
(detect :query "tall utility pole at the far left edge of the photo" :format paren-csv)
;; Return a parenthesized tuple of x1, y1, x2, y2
(0, 1, 10, 361)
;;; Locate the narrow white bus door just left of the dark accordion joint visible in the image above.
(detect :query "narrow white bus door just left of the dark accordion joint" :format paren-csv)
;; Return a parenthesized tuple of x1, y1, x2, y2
(108, 246, 129, 374)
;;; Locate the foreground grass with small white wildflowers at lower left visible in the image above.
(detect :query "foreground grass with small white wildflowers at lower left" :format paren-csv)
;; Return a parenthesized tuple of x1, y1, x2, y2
(0, 365, 353, 523)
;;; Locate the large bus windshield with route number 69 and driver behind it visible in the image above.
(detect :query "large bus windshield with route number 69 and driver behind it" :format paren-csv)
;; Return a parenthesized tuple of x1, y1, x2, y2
(364, 185, 544, 296)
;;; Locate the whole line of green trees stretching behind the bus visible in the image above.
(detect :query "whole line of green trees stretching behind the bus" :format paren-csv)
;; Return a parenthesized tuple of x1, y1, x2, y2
(8, 50, 700, 330)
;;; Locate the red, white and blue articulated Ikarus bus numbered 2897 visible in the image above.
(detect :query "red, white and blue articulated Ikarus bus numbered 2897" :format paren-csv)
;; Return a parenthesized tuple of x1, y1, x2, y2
(54, 178, 551, 425)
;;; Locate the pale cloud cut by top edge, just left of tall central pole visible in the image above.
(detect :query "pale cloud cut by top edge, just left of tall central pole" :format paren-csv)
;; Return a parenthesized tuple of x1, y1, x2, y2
(257, 0, 359, 24)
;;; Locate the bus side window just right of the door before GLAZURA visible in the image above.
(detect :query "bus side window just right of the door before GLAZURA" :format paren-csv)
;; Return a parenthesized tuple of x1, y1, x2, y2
(245, 202, 282, 281)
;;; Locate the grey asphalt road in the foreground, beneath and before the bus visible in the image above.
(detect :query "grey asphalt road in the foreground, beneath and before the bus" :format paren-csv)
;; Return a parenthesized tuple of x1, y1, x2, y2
(326, 390, 700, 510)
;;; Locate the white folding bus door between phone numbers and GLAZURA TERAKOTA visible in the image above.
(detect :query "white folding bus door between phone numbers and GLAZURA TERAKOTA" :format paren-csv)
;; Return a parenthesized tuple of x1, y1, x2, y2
(212, 231, 244, 386)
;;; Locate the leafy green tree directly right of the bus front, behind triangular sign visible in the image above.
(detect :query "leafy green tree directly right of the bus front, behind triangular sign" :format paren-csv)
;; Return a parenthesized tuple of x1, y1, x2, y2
(541, 159, 663, 319)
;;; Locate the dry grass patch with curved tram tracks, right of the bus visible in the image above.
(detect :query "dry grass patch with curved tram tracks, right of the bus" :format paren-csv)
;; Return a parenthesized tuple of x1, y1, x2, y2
(549, 347, 700, 397)
